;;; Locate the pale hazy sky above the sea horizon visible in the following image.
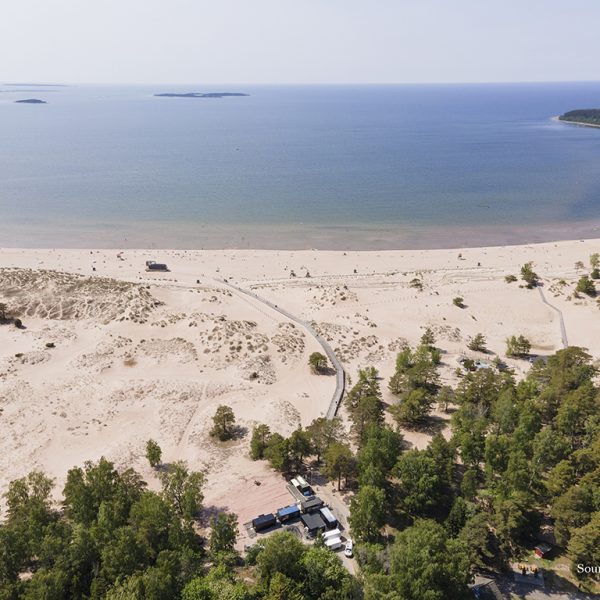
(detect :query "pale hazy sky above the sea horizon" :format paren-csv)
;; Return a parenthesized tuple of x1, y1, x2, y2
(0, 0, 600, 83)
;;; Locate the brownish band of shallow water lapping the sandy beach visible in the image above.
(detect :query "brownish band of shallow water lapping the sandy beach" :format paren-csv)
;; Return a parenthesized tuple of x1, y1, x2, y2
(0, 219, 600, 251)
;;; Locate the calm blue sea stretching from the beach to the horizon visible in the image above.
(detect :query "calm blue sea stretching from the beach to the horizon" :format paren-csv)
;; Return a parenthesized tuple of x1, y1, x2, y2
(0, 83, 600, 248)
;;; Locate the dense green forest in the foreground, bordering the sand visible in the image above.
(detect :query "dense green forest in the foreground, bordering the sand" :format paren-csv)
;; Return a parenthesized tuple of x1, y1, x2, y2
(0, 342, 600, 600)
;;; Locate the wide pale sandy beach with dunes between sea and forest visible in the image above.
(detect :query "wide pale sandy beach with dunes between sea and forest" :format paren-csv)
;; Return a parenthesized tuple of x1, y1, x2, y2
(0, 240, 600, 522)
